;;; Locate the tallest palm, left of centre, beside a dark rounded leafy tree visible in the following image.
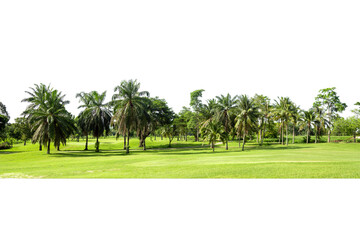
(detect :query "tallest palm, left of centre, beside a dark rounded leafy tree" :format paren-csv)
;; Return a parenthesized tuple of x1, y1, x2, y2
(111, 80, 150, 153)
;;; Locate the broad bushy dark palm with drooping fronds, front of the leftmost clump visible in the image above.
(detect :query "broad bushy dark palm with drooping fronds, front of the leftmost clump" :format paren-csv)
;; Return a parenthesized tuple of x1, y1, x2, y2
(28, 90, 75, 154)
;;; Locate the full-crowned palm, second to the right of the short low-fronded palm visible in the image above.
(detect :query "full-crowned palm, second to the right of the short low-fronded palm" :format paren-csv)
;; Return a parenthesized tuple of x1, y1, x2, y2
(235, 95, 259, 151)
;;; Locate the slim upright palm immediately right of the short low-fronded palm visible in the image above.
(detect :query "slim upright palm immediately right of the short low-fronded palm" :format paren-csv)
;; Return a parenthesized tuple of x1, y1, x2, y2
(216, 94, 237, 150)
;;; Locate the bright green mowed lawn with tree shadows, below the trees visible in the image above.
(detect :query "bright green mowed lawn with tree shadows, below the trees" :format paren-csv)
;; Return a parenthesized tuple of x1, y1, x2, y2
(0, 138, 360, 178)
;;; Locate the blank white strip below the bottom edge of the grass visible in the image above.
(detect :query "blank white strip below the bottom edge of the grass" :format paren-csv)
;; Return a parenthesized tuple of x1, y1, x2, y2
(0, 179, 360, 240)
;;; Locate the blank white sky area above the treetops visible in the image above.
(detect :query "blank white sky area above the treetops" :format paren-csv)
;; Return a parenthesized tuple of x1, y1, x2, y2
(0, 0, 360, 121)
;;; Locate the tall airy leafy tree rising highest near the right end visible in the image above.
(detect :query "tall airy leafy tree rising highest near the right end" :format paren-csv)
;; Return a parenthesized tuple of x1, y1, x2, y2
(314, 87, 347, 142)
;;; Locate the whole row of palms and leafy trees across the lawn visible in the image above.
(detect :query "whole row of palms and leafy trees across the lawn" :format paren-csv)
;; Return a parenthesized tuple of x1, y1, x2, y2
(0, 80, 360, 154)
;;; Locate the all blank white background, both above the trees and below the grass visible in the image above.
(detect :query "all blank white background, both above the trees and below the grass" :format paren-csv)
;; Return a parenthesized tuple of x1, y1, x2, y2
(0, 0, 360, 240)
